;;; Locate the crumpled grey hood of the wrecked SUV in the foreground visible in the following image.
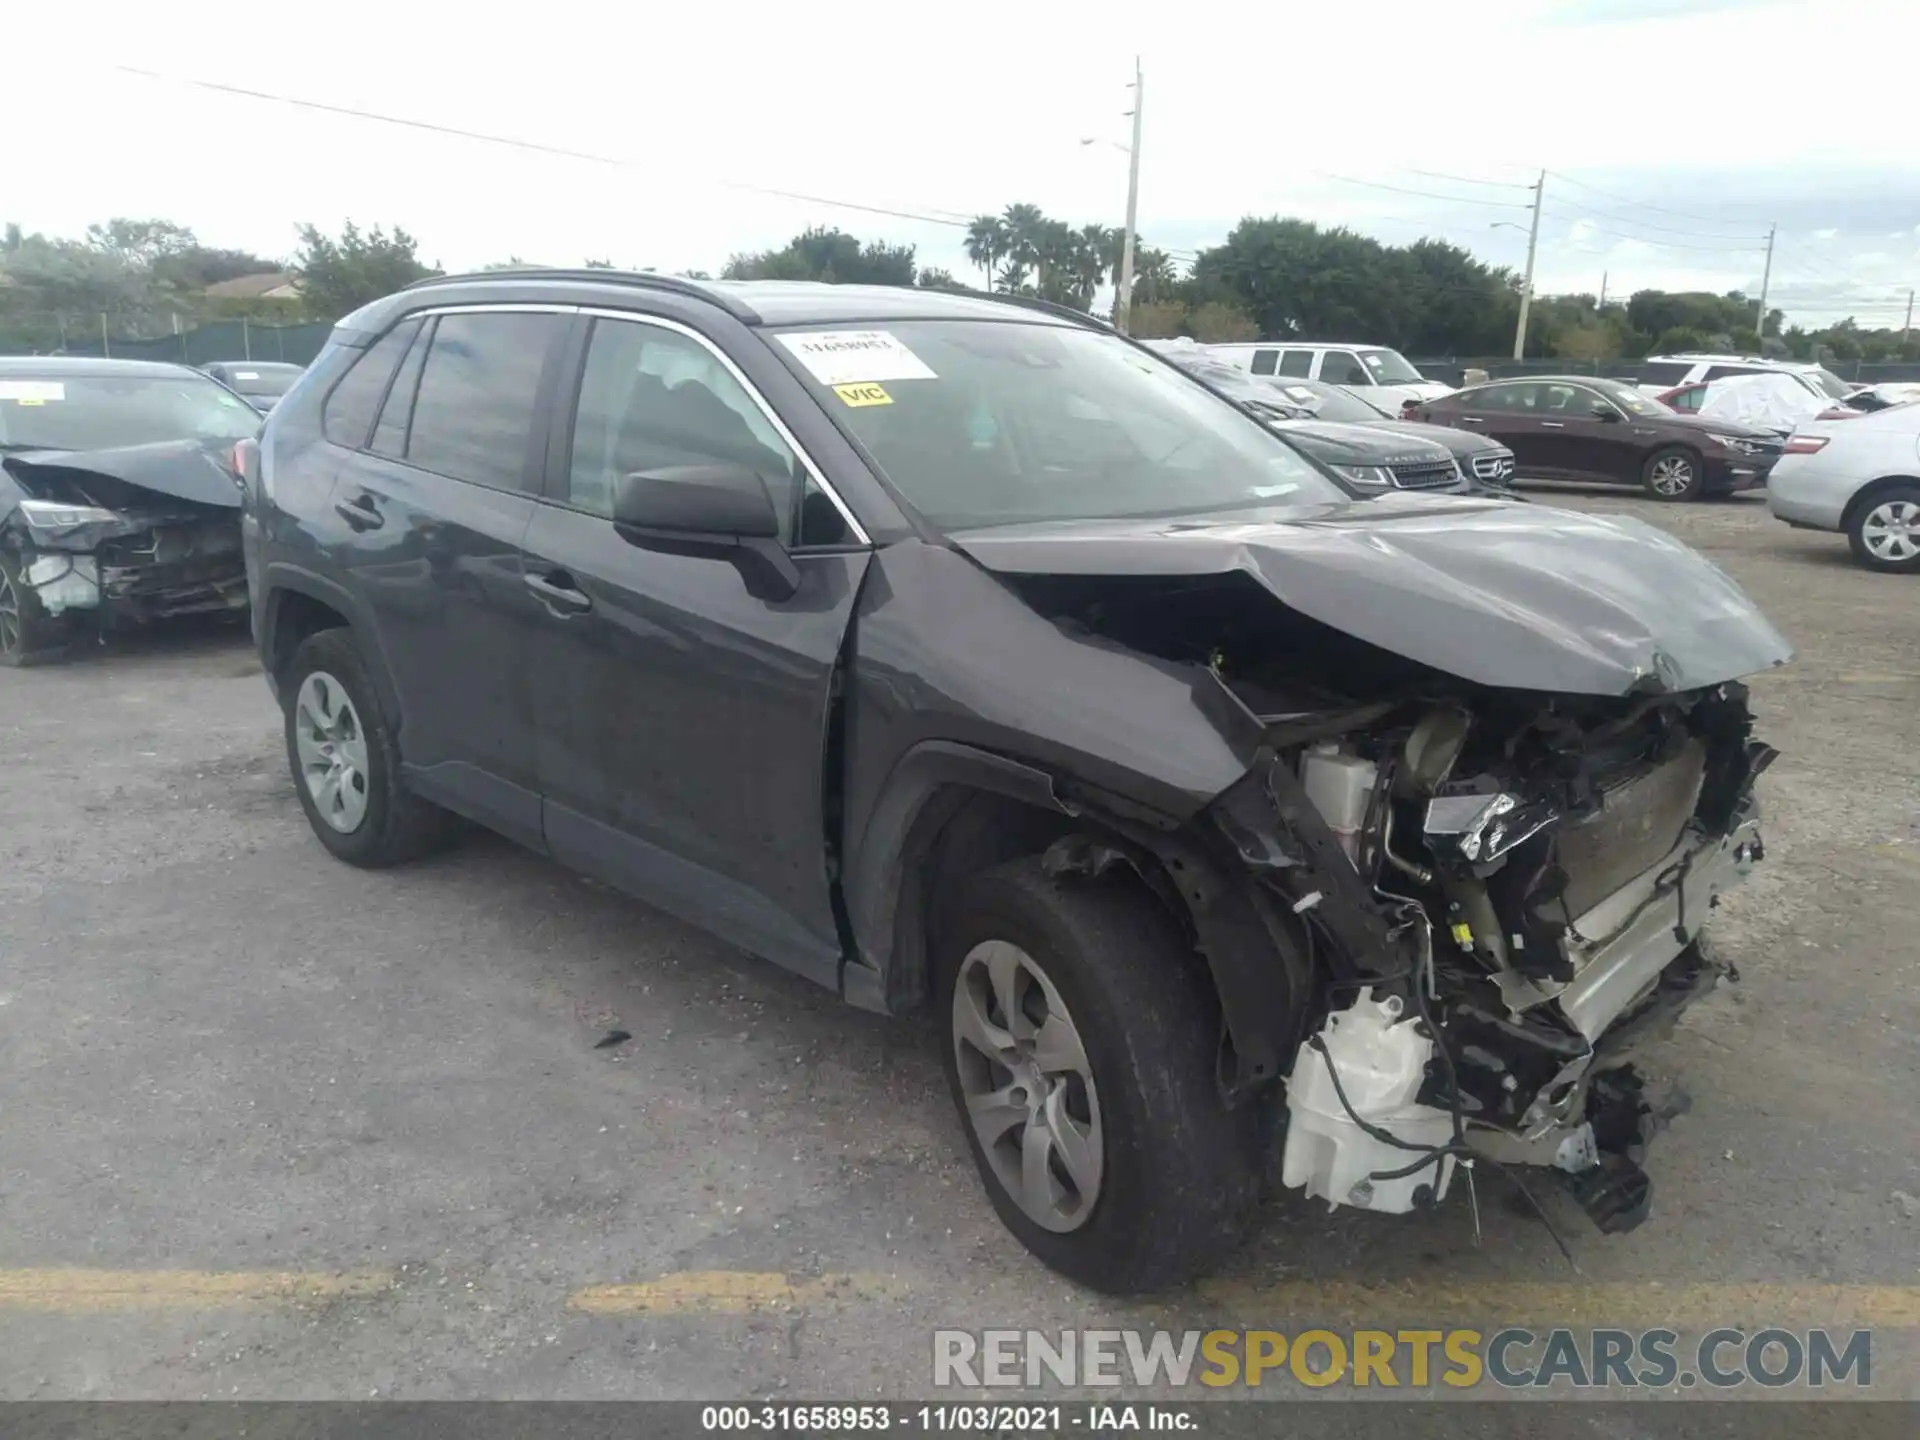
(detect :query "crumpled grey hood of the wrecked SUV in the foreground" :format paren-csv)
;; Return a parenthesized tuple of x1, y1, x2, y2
(952, 492, 1793, 695)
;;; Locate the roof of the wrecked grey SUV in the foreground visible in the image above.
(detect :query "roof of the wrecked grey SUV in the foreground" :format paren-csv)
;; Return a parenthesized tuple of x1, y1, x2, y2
(407, 269, 1082, 328)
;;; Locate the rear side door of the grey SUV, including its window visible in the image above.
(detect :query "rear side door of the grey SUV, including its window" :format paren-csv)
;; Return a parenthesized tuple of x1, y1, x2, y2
(332, 307, 570, 847)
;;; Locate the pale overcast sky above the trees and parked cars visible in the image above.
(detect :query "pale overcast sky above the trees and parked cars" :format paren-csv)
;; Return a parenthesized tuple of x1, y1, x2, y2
(15, 0, 1920, 324)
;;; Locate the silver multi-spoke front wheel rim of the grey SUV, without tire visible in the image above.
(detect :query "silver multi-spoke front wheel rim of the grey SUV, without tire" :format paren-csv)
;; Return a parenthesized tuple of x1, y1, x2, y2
(952, 941, 1106, 1233)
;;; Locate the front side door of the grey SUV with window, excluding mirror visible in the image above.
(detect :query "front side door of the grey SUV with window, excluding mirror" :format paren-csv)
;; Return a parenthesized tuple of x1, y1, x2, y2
(526, 317, 868, 985)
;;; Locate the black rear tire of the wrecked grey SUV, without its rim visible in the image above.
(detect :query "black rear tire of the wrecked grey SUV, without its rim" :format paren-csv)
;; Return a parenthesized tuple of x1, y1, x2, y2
(280, 630, 453, 870)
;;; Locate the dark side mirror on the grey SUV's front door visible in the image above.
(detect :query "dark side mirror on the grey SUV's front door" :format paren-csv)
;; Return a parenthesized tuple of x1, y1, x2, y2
(612, 465, 801, 601)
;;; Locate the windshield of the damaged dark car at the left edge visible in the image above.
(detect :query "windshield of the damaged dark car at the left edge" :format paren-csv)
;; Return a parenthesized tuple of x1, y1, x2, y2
(0, 371, 259, 449)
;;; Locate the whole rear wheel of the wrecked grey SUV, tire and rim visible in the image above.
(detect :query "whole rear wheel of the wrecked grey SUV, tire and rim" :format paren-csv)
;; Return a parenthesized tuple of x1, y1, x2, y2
(280, 630, 451, 870)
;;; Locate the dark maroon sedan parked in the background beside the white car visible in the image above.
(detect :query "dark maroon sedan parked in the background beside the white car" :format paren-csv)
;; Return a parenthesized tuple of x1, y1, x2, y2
(1411, 374, 1780, 501)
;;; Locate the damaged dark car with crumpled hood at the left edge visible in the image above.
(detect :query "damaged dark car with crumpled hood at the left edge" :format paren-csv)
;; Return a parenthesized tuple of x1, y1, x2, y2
(0, 357, 261, 664)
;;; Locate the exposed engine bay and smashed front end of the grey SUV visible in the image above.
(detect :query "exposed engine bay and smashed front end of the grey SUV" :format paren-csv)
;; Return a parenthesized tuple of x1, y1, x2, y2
(1021, 578, 1774, 1231)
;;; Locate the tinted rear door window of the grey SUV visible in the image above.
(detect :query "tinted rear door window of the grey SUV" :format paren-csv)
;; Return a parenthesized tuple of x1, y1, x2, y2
(407, 313, 559, 490)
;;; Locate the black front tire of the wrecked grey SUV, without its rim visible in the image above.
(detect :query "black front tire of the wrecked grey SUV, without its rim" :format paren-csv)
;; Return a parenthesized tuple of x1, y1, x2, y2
(935, 858, 1263, 1294)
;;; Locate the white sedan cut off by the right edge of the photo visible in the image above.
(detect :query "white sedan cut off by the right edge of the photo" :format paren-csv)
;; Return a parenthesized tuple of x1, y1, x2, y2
(1766, 401, 1920, 574)
